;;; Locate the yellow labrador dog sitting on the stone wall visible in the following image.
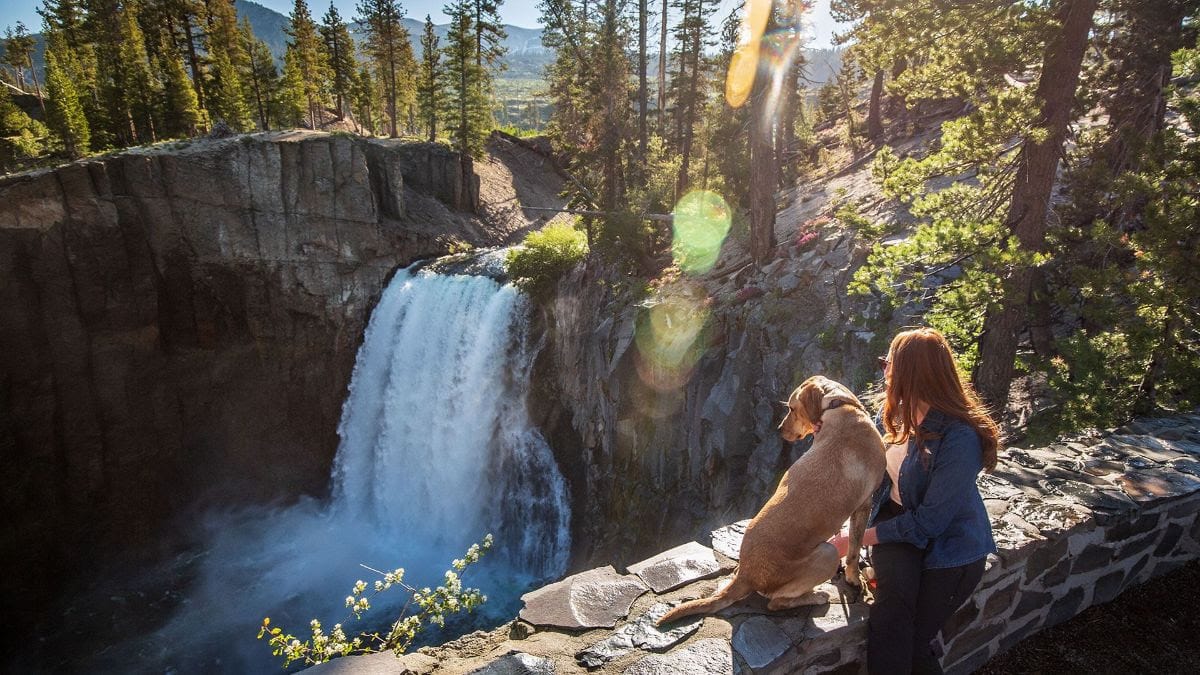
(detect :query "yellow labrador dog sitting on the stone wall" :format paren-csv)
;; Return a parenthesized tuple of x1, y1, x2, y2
(659, 376, 886, 625)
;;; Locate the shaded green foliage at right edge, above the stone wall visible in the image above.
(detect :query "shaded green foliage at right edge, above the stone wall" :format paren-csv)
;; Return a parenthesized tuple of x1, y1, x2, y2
(1031, 74, 1200, 434)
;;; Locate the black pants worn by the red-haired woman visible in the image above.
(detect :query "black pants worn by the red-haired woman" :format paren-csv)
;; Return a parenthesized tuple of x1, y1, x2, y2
(866, 500, 985, 675)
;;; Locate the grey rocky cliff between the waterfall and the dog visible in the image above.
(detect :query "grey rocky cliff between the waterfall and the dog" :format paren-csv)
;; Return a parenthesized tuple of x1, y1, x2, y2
(534, 159, 905, 567)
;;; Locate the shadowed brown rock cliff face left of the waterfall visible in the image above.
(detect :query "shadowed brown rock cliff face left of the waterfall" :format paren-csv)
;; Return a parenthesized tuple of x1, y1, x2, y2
(0, 133, 511, 624)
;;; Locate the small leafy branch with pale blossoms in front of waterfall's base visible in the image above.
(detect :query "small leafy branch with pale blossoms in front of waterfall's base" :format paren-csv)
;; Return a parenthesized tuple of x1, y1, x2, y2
(258, 534, 492, 668)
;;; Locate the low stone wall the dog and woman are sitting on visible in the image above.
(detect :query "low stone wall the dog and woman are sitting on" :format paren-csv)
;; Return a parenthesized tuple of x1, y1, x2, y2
(336, 413, 1200, 675)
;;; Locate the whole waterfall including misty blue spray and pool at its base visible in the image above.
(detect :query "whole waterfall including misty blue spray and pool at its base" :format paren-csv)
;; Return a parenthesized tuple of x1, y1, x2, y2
(137, 253, 570, 671)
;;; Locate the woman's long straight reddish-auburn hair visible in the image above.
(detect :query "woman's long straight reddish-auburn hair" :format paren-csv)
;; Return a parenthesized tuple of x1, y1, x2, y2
(882, 328, 1000, 473)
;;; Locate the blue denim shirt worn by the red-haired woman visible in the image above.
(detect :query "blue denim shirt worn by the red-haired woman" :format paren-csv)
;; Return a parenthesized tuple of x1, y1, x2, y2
(868, 410, 996, 569)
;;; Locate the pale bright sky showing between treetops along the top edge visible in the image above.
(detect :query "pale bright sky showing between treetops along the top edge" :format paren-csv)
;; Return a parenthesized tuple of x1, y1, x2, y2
(0, 0, 836, 47)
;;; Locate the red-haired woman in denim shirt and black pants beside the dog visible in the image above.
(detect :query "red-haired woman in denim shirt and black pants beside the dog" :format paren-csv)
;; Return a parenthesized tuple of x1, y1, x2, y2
(829, 328, 1000, 674)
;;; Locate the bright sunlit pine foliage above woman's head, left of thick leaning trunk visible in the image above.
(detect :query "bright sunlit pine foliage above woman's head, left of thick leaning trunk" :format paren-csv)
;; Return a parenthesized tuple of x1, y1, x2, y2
(854, 82, 1046, 372)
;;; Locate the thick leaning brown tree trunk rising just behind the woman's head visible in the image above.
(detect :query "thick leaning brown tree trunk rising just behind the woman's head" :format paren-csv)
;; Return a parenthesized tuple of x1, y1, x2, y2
(974, 0, 1097, 411)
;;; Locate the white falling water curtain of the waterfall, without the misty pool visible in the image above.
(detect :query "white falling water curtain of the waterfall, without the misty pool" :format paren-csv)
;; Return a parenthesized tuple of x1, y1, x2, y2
(332, 265, 569, 578)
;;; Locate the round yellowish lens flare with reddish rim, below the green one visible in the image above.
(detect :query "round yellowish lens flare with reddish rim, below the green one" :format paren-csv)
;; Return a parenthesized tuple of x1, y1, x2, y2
(634, 291, 708, 392)
